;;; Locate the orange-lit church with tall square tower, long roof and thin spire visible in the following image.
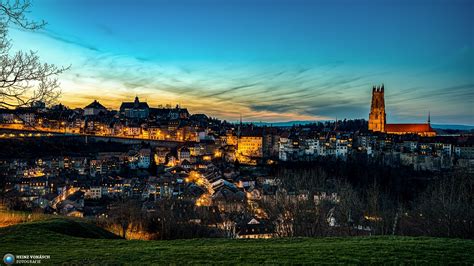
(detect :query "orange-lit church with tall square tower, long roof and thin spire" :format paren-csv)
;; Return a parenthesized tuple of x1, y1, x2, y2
(369, 85, 436, 137)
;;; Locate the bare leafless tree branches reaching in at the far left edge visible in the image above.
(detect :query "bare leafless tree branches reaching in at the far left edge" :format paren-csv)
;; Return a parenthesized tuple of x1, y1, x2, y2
(0, 0, 68, 109)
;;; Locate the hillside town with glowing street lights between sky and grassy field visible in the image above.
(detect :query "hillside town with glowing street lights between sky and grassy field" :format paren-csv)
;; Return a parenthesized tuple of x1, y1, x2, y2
(0, 86, 474, 239)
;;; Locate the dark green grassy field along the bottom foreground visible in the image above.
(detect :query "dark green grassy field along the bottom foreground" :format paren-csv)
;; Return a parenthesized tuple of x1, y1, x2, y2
(0, 218, 474, 265)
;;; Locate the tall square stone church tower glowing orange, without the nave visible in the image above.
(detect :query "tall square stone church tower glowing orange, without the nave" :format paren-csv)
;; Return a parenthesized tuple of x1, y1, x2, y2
(369, 84, 386, 132)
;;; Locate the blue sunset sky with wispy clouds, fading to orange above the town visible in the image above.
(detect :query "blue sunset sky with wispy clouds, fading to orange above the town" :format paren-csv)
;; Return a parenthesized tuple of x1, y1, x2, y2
(9, 0, 474, 125)
